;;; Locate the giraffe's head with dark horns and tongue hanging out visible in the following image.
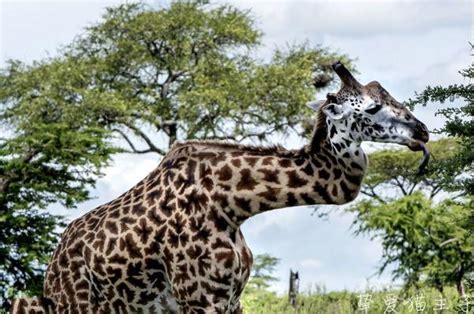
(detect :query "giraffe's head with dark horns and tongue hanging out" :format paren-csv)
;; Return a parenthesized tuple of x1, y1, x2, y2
(310, 62, 429, 169)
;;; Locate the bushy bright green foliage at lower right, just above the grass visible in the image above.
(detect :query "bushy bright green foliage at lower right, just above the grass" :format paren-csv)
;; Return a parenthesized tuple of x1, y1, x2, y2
(351, 192, 474, 291)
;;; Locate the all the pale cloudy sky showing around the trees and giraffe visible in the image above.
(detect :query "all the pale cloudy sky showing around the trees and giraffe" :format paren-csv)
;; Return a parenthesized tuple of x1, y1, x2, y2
(0, 0, 474, 292)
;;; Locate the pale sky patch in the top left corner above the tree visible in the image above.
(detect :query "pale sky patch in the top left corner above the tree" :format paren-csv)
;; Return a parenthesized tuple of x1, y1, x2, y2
(0, 0, 122, 65)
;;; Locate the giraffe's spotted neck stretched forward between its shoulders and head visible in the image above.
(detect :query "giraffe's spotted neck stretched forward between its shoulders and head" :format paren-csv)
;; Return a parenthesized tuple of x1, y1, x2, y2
(211, 113, 367, 226)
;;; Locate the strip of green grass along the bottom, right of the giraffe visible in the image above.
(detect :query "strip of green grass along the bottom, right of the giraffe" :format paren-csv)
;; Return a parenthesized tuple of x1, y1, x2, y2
(241, 288, 474, 314)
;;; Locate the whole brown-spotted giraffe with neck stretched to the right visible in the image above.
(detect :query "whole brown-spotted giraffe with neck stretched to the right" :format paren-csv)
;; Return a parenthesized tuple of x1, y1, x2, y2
(11, 62, 429, 313)
